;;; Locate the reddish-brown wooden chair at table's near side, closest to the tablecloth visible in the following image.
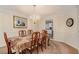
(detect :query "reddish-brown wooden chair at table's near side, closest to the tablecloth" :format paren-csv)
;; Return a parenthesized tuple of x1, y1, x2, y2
(23, 32, 40, 54)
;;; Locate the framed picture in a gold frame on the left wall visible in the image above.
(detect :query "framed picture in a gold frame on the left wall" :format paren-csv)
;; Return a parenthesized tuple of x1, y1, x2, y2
(13, 16, 27, 28)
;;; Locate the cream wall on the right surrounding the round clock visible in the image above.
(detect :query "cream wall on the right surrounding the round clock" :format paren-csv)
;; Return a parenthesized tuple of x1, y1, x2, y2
(41, 6, 79, 49)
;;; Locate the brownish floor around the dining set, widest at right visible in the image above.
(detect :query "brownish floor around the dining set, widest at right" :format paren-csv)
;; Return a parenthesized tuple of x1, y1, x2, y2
(0, 40, 78, 54)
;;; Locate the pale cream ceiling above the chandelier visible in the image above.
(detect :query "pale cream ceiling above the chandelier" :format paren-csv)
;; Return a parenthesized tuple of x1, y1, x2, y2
(0, 5, 75, 15)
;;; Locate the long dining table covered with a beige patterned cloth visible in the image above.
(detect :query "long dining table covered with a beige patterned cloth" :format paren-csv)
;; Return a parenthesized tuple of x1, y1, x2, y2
(9, 35, 32, 53)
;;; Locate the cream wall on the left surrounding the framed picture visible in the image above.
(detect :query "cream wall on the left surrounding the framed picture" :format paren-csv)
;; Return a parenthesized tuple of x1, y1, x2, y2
(0, 9, 39, 47)
